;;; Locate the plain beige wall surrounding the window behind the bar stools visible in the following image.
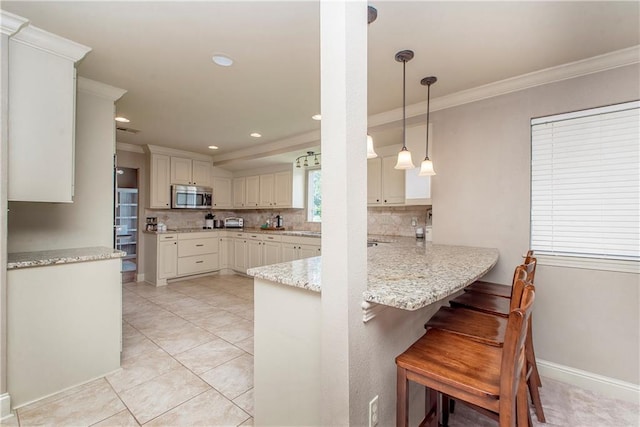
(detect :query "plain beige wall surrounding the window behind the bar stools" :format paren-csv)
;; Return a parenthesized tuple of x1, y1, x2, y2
(432, 65, 640, 384)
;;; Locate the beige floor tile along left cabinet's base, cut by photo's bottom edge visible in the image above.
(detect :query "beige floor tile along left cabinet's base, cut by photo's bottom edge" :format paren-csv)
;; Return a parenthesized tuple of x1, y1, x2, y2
(18, 379, 125, 426)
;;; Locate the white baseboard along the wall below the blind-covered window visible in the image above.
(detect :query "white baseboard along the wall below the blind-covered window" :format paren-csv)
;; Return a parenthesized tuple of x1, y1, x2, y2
(537, 359, 640, 404)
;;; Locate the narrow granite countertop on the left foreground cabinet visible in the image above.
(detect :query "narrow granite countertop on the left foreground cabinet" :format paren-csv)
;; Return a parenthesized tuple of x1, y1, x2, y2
(7, 246, 126, 270)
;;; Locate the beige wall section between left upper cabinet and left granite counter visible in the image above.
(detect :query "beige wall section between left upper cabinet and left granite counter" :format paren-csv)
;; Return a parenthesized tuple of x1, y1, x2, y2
(8, 91, 115, 252)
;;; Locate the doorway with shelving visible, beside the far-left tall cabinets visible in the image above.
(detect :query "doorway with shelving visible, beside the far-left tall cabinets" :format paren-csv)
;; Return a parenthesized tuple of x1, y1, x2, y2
(114, 167, 138, 283)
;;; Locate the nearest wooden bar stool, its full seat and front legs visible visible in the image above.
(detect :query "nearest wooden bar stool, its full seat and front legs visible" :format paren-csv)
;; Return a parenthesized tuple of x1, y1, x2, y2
(396, 281, 535, 427)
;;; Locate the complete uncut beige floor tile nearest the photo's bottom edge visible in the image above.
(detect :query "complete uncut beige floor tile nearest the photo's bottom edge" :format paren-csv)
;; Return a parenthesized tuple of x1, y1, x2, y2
(120, 367, 209, 424)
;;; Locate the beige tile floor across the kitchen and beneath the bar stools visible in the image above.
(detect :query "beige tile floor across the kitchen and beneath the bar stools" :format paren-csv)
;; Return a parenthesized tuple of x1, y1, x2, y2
(0, 275, 640, 427)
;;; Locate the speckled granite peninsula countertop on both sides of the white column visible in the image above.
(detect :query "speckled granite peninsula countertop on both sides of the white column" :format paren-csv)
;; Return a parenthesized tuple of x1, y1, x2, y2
(247, 236, 498, 310)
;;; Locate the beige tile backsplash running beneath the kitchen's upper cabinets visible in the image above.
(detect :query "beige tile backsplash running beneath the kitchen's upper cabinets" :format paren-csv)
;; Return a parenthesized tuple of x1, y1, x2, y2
(145, 206, 431, 236)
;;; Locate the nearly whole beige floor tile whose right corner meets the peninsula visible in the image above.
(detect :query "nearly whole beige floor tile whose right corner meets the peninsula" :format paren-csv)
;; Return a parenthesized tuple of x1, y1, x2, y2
(200, 354, 253, 399)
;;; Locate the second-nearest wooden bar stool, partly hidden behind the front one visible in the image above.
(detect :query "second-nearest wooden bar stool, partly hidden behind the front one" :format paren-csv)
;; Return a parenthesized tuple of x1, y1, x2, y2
(432, 258, 546, 422)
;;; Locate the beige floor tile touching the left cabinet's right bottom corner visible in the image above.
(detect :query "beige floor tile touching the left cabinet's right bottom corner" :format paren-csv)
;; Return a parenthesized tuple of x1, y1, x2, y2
(106, 347, 180, 393)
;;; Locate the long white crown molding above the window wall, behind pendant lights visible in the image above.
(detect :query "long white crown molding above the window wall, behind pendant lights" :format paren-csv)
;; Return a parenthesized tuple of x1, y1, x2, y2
(369, 45, 640, 128)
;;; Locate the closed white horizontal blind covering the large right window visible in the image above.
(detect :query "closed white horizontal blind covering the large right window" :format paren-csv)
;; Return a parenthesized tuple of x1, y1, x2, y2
(531, 101, 640, 261)
